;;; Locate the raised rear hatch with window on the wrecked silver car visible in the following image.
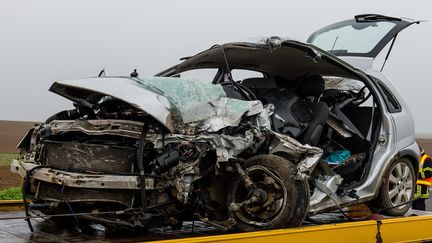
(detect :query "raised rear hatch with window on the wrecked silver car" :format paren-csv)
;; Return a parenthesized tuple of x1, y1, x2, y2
(307, 14, 420, 69)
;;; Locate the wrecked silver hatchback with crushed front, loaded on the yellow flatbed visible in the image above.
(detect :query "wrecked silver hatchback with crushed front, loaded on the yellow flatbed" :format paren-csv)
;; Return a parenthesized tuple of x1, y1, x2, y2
(11, 15, 419, 231)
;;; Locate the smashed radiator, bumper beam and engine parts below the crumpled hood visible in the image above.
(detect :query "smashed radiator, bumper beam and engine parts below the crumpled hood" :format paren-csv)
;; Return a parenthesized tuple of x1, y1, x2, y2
(11, 117, 321, 227)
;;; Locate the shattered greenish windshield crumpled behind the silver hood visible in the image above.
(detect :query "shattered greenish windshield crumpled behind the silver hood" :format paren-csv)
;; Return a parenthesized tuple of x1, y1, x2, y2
(132, 77, 261, 130)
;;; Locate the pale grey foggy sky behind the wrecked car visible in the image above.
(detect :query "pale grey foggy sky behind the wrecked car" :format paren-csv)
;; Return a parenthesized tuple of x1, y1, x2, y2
(0, 0, 432, 134)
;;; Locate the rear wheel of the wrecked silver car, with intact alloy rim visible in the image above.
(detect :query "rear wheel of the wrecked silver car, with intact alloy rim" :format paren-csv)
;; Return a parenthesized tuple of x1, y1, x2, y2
(373, 158, 417, 216)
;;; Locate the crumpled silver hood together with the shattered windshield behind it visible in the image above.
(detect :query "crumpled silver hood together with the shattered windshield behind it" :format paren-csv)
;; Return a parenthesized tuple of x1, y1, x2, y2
(50, 77, 263, 132)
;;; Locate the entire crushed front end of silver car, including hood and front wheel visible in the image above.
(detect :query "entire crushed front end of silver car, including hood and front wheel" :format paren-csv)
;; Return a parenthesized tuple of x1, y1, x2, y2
(11, 78, 340, 230)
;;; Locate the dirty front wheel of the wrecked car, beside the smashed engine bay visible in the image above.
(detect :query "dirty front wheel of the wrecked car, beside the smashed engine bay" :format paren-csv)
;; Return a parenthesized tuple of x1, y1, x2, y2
(227, 154, 309, 231)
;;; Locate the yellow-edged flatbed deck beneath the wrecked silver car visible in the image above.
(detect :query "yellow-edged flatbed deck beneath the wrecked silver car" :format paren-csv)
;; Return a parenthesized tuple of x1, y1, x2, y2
(0, 201, 432, 243)
